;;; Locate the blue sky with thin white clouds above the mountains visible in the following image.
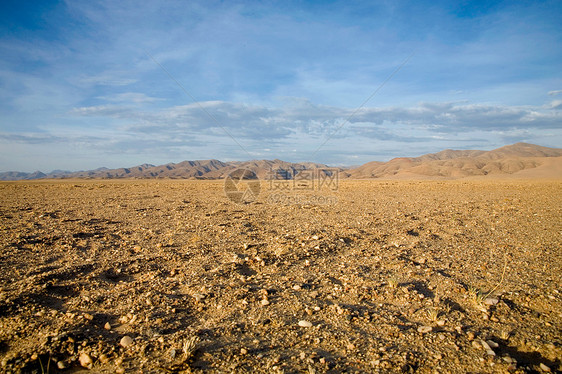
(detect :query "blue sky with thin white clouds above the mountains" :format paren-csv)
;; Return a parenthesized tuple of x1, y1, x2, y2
(0, 0, 562, 172)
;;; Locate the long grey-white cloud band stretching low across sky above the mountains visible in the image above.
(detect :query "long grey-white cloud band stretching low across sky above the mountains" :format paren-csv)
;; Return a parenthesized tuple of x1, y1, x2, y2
(71, 99, 562, 139)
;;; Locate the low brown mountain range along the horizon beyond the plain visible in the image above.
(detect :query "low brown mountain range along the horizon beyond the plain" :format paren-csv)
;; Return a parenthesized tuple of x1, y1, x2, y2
(0, 143, 562, 180)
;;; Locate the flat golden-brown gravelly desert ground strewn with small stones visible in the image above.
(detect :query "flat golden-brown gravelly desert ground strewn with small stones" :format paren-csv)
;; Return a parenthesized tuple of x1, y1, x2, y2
(0, 180, 562, 373)
